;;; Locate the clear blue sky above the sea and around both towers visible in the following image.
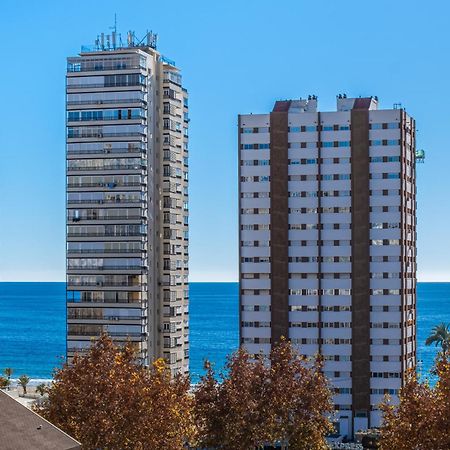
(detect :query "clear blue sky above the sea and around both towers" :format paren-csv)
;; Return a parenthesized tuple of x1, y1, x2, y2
(0, 0, 450, 281)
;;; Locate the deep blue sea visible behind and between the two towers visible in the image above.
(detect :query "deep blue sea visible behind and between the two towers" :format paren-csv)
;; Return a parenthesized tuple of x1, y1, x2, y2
(0, 283, 450, 382)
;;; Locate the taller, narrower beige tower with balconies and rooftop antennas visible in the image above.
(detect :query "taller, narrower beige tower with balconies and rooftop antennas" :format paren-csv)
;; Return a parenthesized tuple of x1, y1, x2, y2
(67, 32, 189, 373)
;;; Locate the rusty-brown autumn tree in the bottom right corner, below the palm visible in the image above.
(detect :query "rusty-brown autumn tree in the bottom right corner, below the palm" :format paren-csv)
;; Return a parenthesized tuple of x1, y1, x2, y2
(381, 352, 450, 450)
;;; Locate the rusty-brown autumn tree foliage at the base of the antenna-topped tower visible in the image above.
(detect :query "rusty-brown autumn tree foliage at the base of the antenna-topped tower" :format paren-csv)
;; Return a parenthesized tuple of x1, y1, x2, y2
(35, 335, 192, 450)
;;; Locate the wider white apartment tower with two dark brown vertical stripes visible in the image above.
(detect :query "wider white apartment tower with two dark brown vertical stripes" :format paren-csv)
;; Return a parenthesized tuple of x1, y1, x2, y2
(239, 95, 416, 436)
